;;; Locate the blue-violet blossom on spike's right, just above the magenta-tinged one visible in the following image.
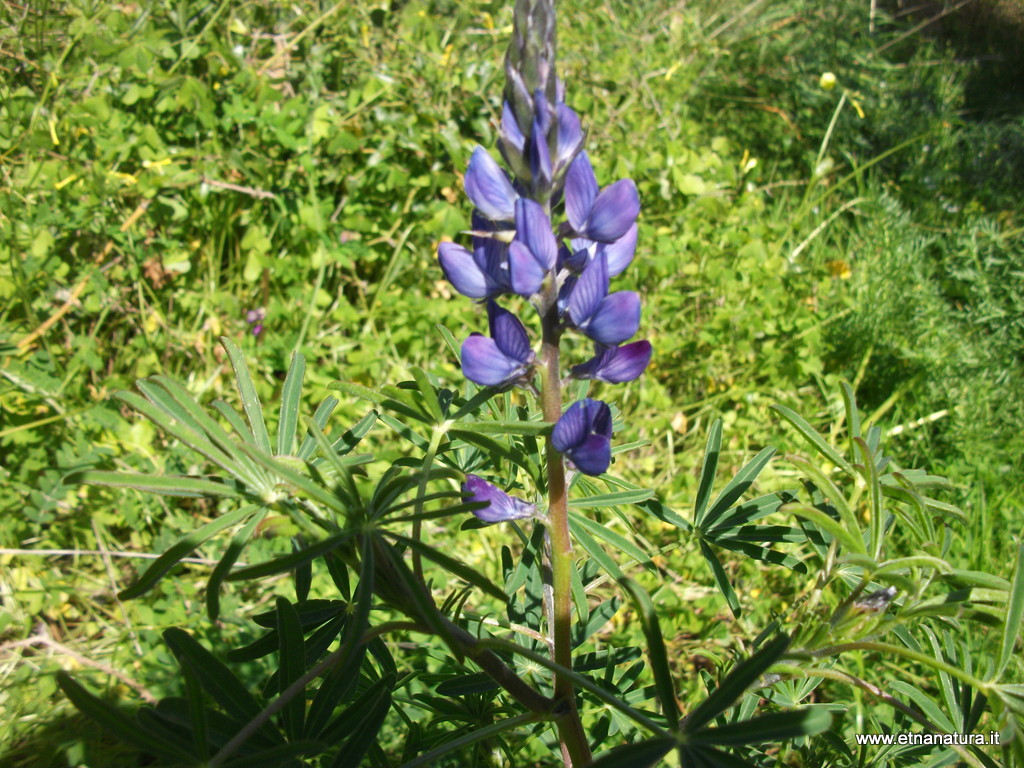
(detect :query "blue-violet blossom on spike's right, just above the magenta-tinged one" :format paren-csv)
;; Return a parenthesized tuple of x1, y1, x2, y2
(564, 253, 640, 346)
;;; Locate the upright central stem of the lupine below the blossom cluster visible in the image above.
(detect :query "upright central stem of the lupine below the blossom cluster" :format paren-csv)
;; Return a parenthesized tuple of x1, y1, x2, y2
(541, 281, 593, 768)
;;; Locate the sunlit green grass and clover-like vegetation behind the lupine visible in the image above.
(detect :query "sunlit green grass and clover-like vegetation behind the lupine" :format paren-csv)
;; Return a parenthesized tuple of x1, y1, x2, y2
(0, 0, 1024, 766)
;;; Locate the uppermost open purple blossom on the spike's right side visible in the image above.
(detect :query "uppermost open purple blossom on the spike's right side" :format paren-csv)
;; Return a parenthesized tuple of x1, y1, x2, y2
(565, 152, 640, 243)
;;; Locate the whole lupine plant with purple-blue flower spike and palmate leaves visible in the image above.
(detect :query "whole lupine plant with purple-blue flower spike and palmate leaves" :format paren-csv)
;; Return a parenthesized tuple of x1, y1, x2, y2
(59, 0, 1024, 768)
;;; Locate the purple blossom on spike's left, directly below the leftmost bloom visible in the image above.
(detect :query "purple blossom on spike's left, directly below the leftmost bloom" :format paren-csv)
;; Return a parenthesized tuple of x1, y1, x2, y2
(462, 301, 535, 387)
